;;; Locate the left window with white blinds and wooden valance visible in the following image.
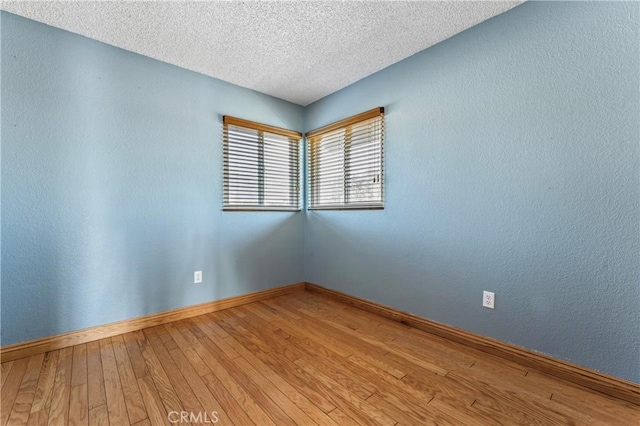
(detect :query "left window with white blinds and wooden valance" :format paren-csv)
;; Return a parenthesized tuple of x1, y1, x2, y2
(222, 115, 302, 211)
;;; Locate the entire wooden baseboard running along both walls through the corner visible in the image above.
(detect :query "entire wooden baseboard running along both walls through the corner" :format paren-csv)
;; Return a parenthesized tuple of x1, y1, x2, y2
(0, 283, 640, 405)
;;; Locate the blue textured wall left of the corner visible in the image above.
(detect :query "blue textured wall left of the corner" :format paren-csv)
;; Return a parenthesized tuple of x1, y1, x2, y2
(1, 12, 304, 345)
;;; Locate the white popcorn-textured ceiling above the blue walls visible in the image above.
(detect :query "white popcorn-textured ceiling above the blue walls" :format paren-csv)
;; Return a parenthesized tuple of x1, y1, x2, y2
(1, 0, 522, 105)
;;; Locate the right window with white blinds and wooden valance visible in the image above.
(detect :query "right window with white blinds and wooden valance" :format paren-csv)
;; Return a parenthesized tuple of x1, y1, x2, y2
(306, 108, 384, 210)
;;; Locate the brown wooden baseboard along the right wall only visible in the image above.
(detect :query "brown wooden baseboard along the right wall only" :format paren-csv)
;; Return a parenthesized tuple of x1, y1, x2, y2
(305, 283, 640, 405)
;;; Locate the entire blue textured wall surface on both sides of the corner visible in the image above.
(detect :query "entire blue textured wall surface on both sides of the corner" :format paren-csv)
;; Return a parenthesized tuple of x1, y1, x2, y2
(0, 2, 640, 382)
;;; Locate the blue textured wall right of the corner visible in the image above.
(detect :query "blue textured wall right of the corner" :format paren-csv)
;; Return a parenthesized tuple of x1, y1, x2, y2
(305, 2, 640, 382)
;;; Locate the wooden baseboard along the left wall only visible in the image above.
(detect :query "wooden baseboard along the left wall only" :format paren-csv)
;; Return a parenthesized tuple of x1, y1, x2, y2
(0, 283, 305, 362)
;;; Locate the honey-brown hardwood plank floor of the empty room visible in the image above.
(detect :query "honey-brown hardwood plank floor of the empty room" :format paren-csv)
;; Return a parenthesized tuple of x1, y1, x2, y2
(0, 291, 640, 426)
